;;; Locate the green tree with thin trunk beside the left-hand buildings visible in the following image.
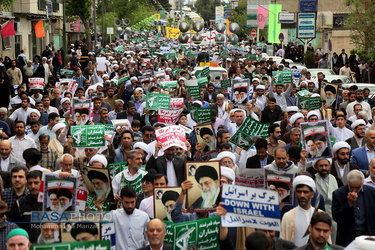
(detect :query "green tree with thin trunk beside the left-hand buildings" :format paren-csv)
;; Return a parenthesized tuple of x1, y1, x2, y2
(65, 0, 92, 51)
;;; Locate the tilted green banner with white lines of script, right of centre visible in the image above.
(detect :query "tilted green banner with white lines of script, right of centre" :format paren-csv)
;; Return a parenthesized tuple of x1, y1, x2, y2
(229, 117, 270, 151)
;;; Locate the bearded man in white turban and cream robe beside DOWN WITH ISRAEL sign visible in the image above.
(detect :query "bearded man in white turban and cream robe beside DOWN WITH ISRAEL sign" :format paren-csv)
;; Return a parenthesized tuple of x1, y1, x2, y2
(280, 175, 315, 247)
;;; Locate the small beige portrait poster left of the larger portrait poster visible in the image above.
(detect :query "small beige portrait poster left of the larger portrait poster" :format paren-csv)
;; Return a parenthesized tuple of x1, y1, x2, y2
(154, 187, 181, 221)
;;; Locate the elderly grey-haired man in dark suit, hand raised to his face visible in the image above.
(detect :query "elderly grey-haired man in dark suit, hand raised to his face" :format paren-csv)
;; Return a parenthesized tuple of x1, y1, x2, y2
(332, 170, 375, 246)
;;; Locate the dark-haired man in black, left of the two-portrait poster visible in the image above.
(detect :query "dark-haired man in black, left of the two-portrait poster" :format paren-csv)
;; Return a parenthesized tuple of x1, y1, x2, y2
(9, 170, 43, 243)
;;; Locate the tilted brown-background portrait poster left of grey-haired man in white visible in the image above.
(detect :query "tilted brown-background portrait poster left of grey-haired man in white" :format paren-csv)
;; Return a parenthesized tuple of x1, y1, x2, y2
(79, 165, 113, 202)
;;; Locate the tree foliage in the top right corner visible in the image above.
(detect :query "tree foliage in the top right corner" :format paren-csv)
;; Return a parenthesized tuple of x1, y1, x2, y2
(346, 0, 375, 53)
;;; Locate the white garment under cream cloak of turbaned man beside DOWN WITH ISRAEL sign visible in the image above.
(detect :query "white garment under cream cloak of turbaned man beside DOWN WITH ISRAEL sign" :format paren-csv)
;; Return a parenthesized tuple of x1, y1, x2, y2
(294, 206, 314, 247)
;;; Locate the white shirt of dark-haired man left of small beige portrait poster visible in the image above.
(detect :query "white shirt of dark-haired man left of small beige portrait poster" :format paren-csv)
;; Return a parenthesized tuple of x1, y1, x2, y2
(104, 208, 150, 250)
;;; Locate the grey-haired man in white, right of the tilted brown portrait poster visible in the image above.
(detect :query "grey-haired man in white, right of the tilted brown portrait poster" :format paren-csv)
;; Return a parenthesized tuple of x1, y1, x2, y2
(112, 149, 146, 200)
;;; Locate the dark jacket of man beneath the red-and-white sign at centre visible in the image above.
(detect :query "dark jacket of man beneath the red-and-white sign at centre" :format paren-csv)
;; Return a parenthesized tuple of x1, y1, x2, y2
(146, 156, 186, 185)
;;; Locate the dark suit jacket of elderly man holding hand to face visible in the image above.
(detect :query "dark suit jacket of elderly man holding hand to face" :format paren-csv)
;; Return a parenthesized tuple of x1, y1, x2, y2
(332, 185, 375, 246)
